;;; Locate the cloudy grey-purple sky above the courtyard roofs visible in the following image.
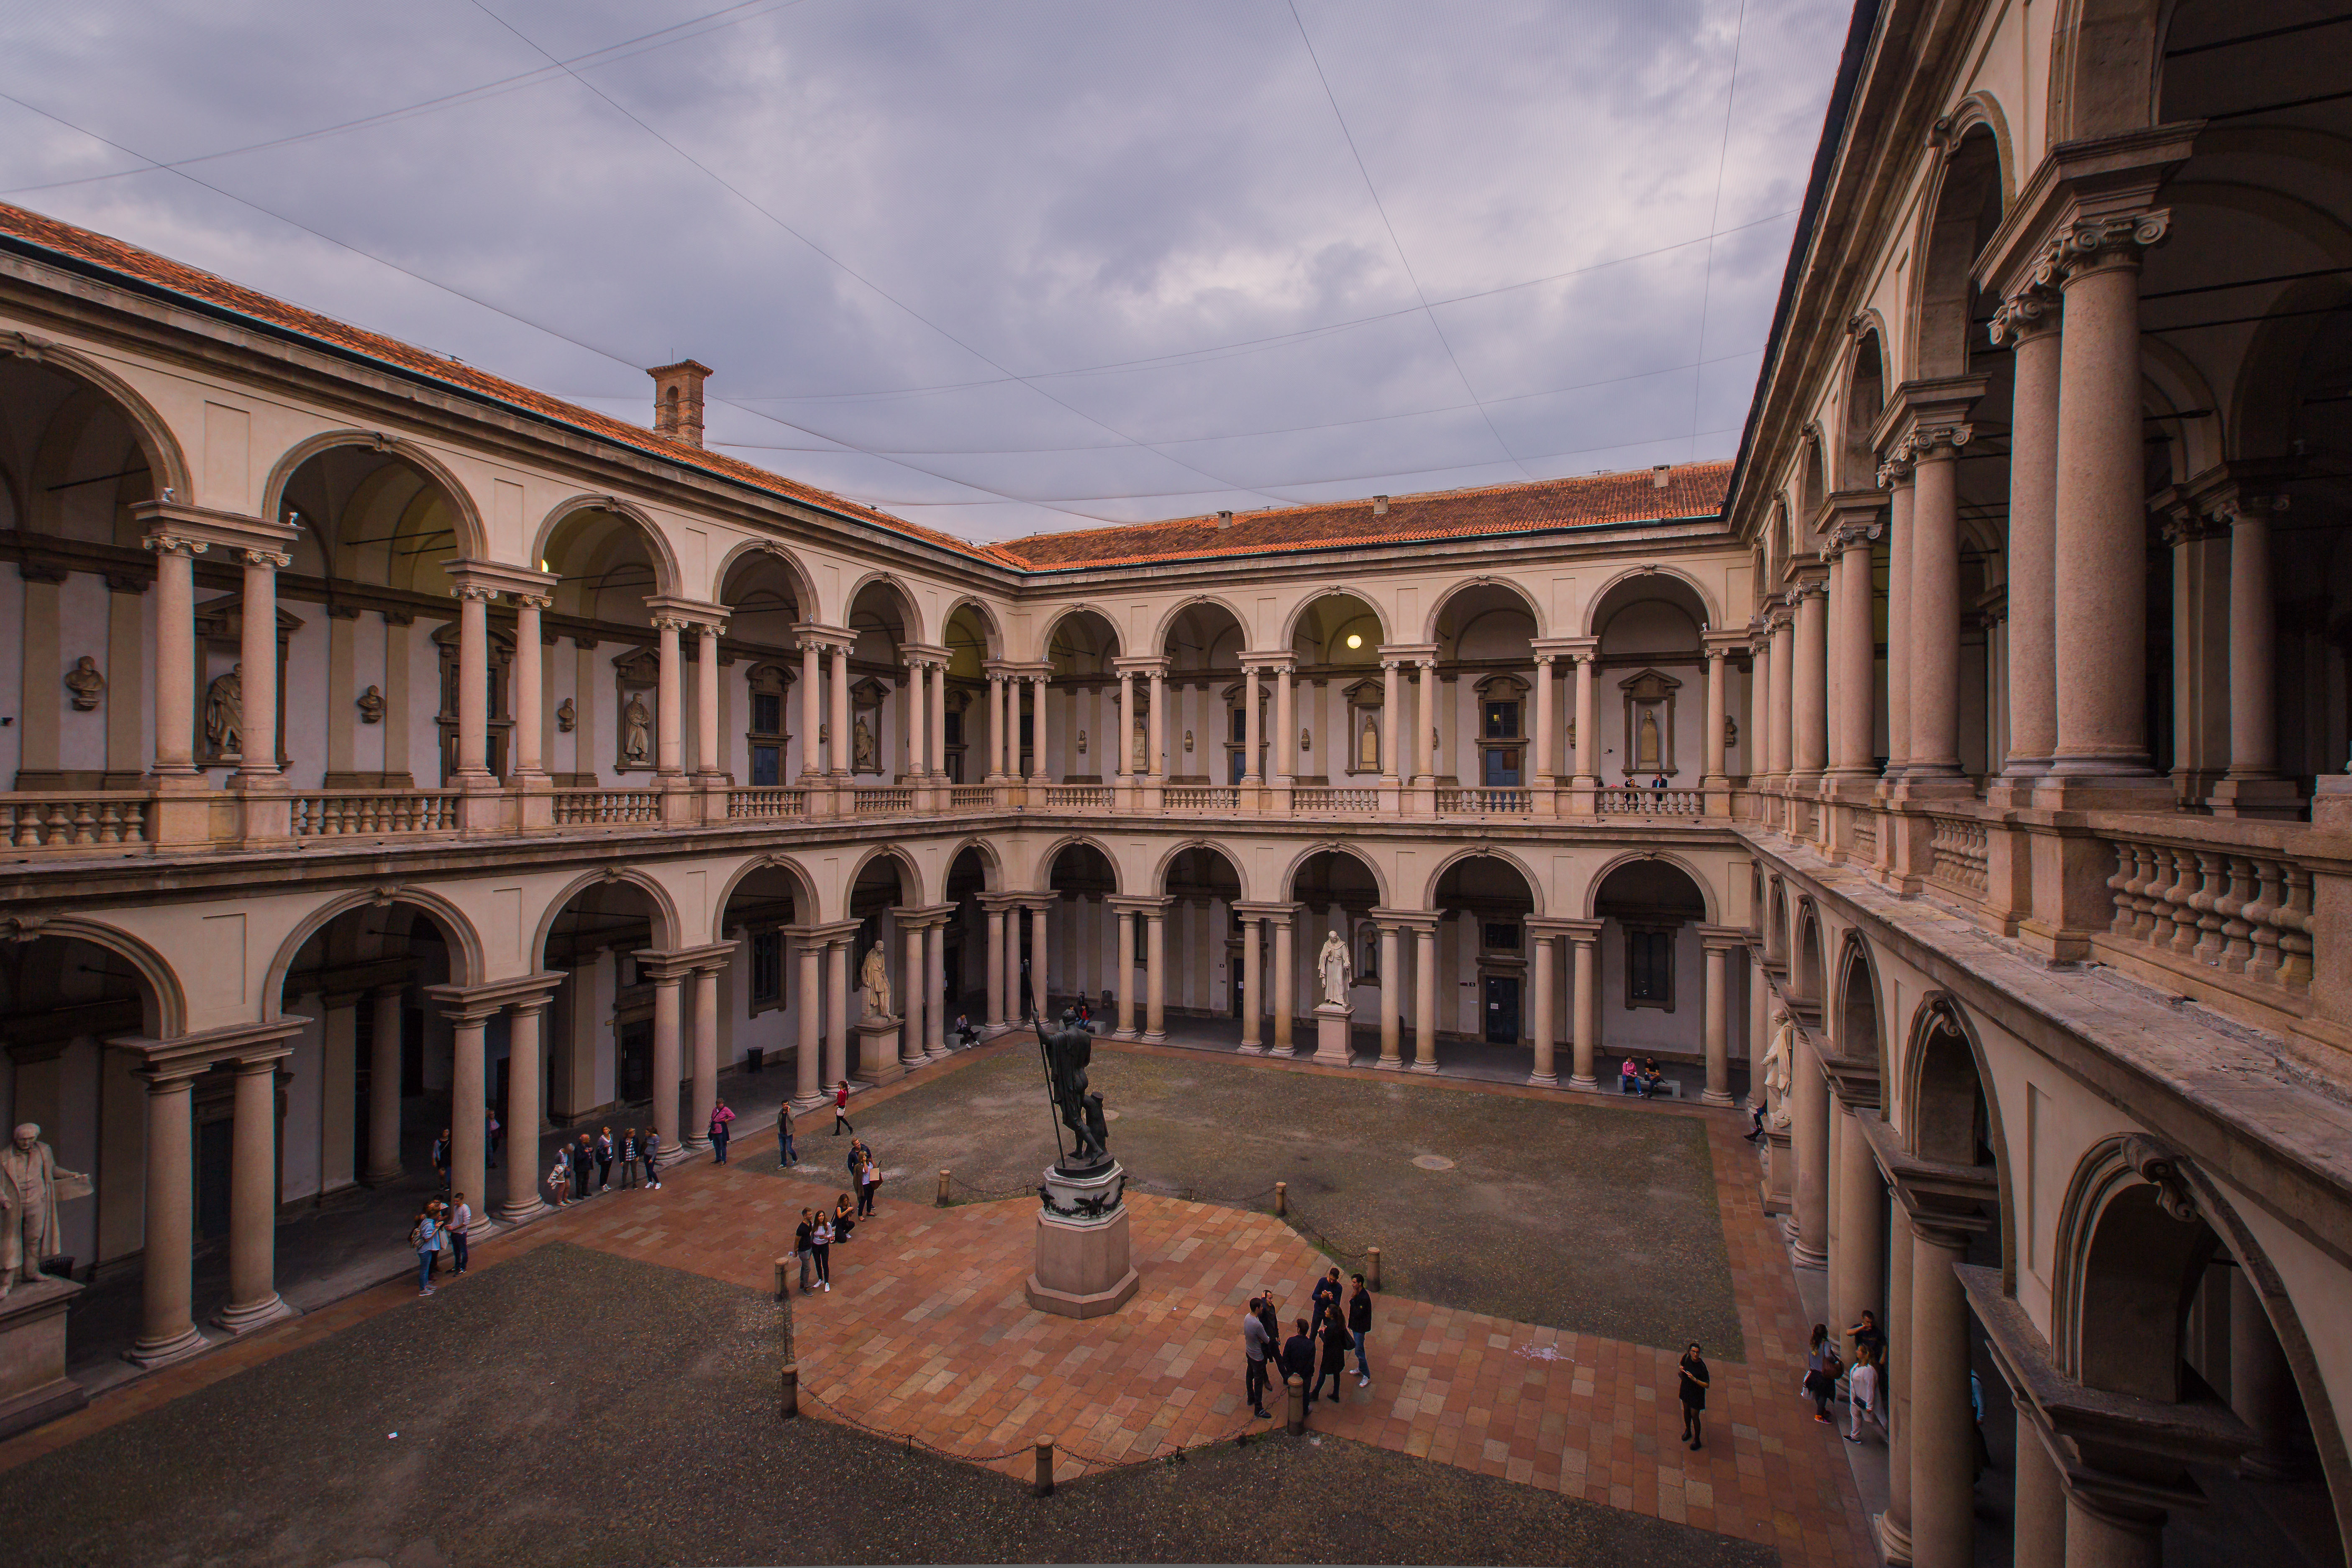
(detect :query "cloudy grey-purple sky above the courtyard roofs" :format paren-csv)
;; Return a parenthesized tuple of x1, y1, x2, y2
(0, 0, 1849, 538)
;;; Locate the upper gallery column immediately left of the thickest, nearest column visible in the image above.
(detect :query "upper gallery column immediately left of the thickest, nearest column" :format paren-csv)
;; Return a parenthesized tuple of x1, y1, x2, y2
(1992, 284, 2058, 785)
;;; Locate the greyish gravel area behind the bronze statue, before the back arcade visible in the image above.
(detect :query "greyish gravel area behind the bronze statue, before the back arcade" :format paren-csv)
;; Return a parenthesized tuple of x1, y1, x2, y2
(776, 1046, 1747, 1361)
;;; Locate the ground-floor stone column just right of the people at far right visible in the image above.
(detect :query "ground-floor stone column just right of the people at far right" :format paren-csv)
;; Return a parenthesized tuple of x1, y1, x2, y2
(1910, 1215, 1985, 1568)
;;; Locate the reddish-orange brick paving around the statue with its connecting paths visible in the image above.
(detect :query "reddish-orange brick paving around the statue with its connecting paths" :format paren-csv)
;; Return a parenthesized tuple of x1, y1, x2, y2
(0, 1051, 1877, 1565)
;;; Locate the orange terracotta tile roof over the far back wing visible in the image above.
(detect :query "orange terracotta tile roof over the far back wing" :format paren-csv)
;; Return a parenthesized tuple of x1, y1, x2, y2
(997, 463, 1731, 569)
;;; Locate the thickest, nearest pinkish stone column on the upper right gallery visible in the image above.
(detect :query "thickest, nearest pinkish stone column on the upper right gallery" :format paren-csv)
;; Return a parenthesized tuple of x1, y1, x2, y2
(2051, 212, 2171, 781)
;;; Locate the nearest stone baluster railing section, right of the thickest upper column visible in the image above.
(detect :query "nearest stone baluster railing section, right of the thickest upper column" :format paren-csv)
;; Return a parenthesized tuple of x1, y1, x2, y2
(2107, 837, 2340, 990)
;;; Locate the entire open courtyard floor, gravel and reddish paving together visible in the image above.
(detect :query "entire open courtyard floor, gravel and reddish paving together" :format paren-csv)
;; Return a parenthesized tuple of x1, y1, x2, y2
(0, 1039, 1868, 1568)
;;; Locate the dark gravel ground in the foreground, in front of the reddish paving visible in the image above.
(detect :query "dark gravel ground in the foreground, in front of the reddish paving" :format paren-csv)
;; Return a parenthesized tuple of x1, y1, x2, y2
(0, 1244, 1773, 1568)
